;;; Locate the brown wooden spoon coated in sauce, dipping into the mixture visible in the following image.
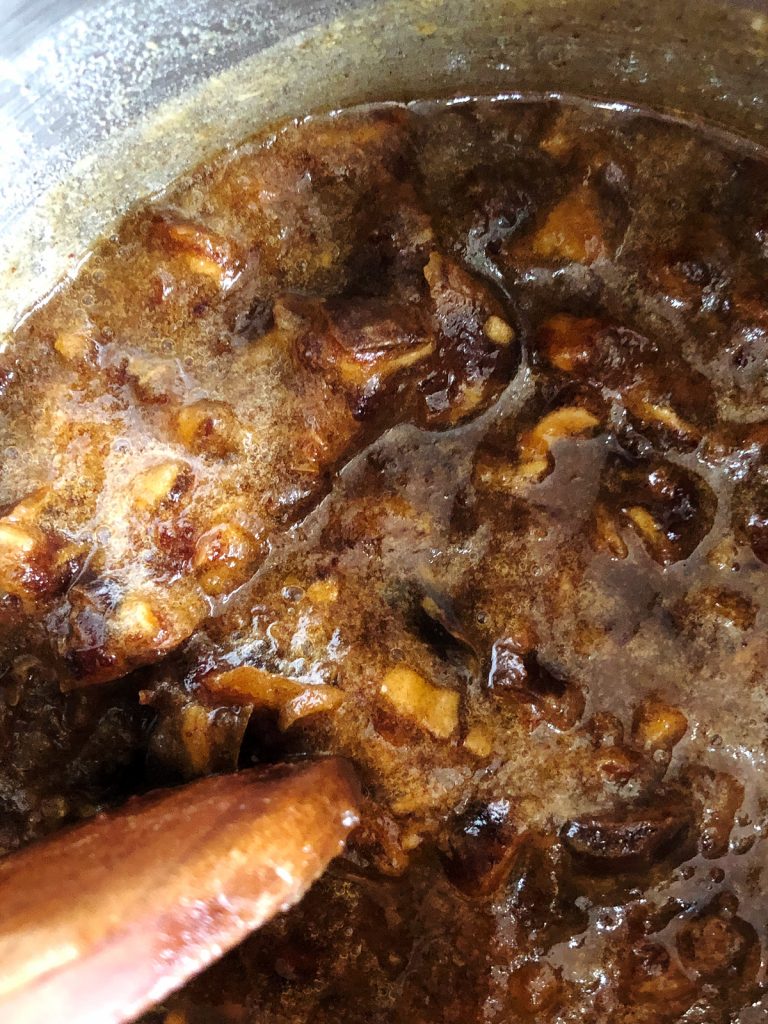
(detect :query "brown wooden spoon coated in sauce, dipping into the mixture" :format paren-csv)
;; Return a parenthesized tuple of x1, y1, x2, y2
(0, 758, 357, 1024)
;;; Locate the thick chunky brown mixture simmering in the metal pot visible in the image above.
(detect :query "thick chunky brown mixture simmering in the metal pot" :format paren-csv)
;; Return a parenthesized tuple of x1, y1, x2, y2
(0, 99, 768, 1024)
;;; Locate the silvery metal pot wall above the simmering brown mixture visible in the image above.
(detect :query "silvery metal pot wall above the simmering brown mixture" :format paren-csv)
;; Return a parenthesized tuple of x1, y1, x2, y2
(0, 0, 768, 330)
